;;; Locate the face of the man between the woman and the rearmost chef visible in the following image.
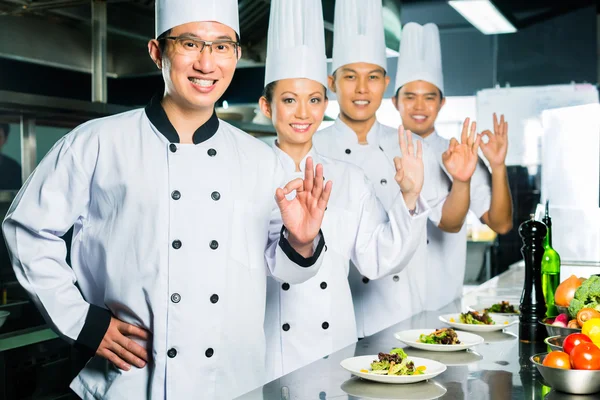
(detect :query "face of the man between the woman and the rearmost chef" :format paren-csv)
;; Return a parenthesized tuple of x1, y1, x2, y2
(329, 63, 390, 122)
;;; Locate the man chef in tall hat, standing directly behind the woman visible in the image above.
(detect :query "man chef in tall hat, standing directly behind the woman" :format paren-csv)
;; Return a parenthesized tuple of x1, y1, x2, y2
(314, 0, 474, 337)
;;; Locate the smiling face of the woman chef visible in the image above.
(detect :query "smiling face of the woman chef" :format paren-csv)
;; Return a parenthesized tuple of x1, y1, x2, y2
(259, 78, 327, 145)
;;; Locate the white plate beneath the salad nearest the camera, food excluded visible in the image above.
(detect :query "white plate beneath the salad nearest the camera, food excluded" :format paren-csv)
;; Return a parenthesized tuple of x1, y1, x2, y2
(340, 355, 446, 383)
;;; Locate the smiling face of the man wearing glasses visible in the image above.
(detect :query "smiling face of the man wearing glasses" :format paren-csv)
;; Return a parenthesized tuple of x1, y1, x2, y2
(148, 21, 241, 109)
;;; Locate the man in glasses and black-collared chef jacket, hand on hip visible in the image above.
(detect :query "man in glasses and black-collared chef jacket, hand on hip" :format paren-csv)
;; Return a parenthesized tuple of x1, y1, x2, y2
(3, 0, 331, 400)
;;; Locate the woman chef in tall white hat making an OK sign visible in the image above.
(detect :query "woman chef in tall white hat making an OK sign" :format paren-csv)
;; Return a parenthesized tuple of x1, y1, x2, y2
(260, 0, 428, 382)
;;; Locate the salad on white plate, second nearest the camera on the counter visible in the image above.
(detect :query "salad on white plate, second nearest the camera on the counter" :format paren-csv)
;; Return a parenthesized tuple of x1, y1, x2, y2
(394, 328, 484, 352)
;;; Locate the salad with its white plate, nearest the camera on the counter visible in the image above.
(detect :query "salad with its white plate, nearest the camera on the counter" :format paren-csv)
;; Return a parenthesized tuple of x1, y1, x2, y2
(340, 349, 446, 383)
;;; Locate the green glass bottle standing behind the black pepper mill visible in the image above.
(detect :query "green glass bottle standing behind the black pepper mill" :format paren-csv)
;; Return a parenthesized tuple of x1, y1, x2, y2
(542, 200, 560, 317)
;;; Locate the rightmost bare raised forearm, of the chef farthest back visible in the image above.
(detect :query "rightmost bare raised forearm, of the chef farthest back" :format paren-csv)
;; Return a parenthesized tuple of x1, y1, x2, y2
(484, 165, 513, 234)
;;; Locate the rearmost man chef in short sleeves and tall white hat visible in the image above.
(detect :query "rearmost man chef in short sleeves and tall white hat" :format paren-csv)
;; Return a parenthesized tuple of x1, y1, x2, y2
(392, 23, 512, 310)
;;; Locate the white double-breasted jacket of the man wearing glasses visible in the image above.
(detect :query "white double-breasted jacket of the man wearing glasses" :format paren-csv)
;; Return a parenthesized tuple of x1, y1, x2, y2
(3, 110, 323, 400)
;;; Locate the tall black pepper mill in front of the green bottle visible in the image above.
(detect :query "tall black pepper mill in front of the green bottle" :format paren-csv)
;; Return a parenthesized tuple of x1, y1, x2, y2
(519, 215, 547, 343)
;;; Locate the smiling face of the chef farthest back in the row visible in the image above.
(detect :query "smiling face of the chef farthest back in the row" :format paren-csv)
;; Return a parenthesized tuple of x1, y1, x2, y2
(392, 81, 446, 137)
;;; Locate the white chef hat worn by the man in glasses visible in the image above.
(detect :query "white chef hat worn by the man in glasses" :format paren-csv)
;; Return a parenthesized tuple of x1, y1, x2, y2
(155, 0, 240, 37)
